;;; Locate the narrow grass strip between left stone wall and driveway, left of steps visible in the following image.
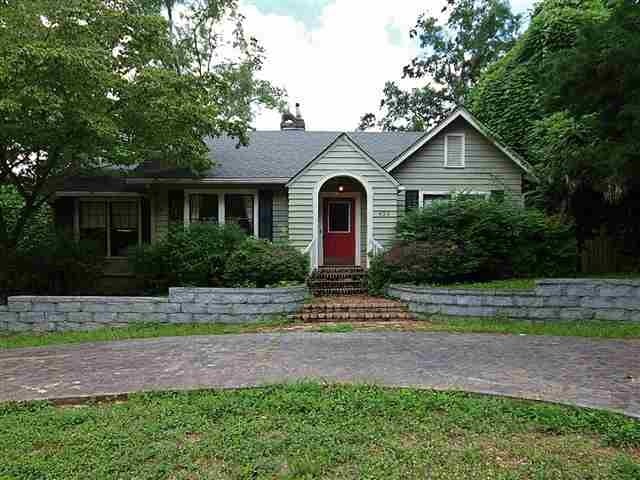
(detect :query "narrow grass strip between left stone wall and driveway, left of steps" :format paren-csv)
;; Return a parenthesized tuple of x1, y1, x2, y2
(0, 318, 290, 348)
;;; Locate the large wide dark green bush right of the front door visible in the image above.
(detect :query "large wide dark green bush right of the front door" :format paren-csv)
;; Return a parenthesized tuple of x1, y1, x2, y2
(369, 198, 577, 292)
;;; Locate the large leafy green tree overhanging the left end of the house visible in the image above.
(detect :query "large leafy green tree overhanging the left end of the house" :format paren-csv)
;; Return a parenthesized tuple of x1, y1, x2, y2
(0, 0, 276, 300)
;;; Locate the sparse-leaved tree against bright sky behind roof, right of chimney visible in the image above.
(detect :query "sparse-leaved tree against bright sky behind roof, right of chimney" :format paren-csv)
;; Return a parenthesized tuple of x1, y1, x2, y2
(360, 0, 521, 130)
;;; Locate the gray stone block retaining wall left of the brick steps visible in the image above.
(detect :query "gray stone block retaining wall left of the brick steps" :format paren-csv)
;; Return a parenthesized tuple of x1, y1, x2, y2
(0, 286, 308, 331)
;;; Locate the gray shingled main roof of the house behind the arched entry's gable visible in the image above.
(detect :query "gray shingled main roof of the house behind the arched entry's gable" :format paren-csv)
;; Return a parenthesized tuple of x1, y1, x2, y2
(134, 130, 422, 183)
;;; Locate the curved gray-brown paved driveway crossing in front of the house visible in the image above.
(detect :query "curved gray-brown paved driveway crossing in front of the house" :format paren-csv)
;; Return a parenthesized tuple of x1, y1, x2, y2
(0, 332, 640, 416)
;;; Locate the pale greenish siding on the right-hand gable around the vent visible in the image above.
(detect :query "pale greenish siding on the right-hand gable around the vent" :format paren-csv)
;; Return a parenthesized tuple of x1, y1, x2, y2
(392, 118, 523, 196)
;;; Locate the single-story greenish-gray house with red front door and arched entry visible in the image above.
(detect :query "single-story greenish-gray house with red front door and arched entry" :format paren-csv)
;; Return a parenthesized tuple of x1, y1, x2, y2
(55, 108, 531, 276)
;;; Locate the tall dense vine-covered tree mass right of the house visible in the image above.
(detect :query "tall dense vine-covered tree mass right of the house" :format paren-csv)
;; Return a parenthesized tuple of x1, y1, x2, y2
(471, 0, 640, 264)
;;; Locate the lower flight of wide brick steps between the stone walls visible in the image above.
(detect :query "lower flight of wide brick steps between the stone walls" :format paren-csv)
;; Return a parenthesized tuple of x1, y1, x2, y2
(295, 296, 415, 323)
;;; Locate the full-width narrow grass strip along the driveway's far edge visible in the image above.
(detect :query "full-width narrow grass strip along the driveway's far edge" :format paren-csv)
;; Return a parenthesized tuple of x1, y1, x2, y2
(0, 316, 640, 348)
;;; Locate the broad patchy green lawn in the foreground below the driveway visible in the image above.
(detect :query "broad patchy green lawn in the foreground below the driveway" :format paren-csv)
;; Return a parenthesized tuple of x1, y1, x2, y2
(0, 383, 640, 480)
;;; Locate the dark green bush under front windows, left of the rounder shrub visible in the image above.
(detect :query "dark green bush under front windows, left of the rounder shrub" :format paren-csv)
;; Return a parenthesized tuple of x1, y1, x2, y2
(129, 225, 245, 291)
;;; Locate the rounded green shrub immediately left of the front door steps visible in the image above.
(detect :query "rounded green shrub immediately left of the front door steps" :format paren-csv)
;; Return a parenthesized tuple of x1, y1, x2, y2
(224, 238, 309, 288)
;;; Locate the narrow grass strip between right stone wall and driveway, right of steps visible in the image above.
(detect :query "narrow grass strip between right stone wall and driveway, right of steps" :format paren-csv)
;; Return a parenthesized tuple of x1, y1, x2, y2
(418, 316, 640, 338)
